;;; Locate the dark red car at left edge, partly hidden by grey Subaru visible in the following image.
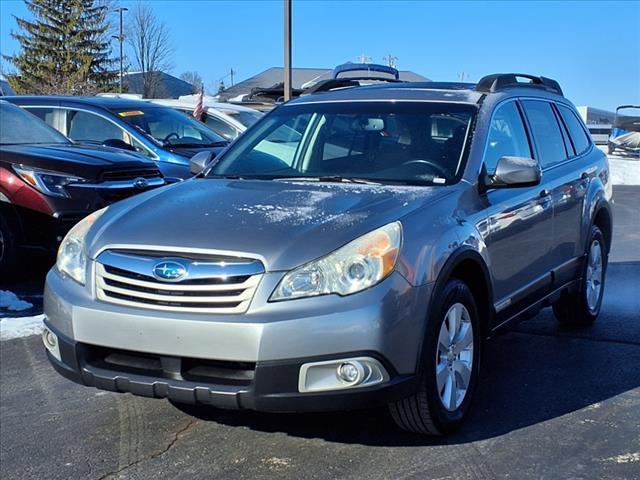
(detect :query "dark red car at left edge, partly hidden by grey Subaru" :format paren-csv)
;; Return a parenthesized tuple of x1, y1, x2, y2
(0, 100, 165, 276)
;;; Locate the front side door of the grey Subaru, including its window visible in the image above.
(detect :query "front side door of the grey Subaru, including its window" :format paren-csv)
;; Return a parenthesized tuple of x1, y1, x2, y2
(484, 100, 553, 320)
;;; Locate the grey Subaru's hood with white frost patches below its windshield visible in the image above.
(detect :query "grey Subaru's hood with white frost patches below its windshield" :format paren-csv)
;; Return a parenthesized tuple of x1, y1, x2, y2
(87, 179, 448, 271)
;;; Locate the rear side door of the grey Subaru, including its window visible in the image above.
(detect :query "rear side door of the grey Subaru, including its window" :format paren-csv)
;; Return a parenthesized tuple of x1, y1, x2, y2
(522, 99, 587, 286)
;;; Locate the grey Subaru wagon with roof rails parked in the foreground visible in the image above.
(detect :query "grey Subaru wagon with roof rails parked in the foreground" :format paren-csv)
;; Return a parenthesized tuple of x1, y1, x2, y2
(44, 74, 612, 434)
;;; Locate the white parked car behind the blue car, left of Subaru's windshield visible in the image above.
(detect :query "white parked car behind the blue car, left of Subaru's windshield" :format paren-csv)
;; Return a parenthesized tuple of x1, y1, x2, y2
(150, 95, 264, 141)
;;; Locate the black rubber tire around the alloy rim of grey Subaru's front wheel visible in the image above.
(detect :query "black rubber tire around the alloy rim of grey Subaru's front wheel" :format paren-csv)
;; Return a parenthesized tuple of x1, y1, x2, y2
(389, 279, 482, 435)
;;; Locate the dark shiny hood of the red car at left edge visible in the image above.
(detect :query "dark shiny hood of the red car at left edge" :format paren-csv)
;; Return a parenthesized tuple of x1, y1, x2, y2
(0, 144, 156, 180)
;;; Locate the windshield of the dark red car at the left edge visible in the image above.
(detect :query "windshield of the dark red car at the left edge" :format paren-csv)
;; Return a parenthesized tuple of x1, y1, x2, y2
(0, 102, 71, 145)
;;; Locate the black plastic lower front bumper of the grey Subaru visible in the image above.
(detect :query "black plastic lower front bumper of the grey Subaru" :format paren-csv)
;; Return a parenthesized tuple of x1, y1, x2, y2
(45, 322, 415, 412)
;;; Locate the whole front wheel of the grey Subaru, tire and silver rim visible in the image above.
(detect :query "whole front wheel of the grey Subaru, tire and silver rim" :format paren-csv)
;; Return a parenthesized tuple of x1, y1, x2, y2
(389, 280, 481, 435)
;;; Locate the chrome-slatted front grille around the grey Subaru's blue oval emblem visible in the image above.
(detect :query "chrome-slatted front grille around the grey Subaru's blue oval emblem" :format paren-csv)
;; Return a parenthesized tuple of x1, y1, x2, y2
(96, 251, 264, 314)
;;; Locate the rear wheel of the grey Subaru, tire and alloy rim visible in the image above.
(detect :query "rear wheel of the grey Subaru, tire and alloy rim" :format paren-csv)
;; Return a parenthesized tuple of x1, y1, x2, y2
(553, 225, 608, 326)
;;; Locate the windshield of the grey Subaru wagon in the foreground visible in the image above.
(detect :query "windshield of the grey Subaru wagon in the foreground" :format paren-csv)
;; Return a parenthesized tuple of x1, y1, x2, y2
(207, 102, 476, 185)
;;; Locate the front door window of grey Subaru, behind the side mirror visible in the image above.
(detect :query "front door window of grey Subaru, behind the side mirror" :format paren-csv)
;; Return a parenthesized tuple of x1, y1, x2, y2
(484, 102, 528, 175)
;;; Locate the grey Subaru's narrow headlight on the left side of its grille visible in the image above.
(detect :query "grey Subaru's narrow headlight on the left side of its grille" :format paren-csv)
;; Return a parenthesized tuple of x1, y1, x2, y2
(56, 207, 107, 285)
